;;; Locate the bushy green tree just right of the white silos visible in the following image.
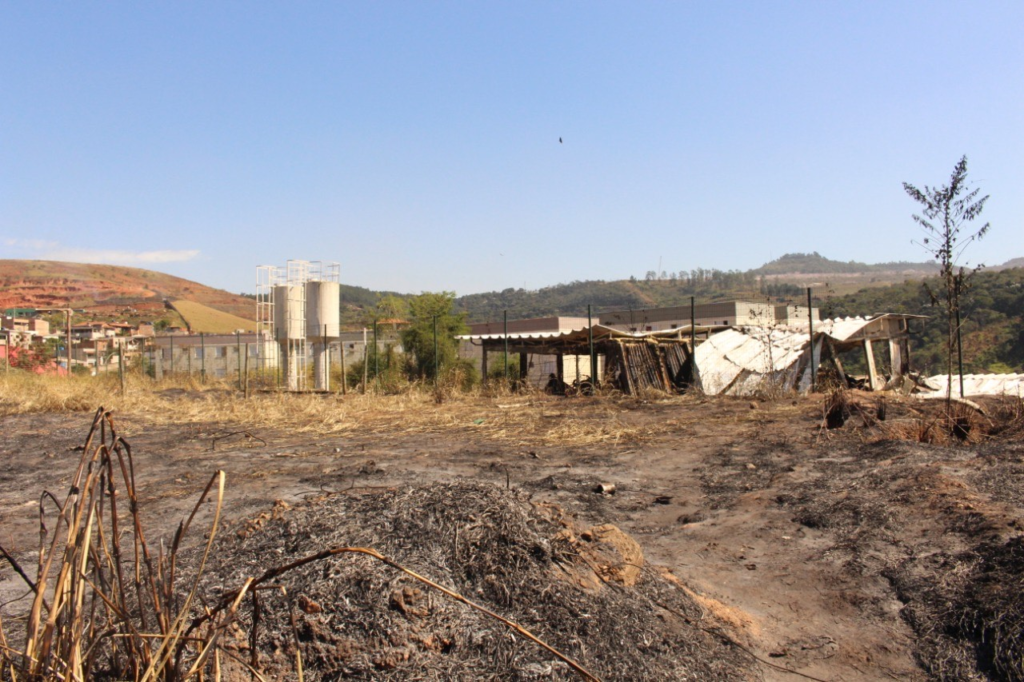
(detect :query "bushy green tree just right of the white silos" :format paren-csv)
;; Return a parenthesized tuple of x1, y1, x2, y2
(401, 291, 469, 379)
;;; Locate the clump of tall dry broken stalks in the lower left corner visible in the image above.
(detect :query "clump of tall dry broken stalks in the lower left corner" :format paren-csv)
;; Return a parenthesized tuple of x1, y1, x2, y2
(0, 409, 233, 681)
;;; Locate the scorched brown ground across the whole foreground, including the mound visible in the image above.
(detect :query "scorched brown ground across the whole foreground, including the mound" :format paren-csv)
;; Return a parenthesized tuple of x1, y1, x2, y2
(0, 395, 1024, 680)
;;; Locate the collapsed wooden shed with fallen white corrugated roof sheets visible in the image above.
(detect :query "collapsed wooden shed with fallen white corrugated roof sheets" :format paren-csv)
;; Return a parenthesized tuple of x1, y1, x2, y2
(459, 313, 920, 395)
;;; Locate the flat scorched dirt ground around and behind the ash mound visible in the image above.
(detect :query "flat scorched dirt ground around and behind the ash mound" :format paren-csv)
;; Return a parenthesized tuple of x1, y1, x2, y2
(0, 398, 1024, 680)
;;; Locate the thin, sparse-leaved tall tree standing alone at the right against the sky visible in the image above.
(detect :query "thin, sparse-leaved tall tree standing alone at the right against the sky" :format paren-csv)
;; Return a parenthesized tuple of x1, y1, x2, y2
(903, 156, 989, 399)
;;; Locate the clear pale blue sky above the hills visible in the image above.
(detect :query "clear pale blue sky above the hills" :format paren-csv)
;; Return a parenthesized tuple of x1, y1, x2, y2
(0, 0, 1024, 294)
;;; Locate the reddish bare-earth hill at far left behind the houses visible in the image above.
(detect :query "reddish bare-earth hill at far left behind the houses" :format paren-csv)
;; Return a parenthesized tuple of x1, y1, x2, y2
(0, 260, 256, 319)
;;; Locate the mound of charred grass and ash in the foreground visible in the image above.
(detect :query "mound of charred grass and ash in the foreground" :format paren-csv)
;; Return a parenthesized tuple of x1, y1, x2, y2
(193, 481, 757, 680)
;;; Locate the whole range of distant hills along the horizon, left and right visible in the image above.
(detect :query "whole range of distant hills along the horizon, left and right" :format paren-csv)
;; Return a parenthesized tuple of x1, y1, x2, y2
(0, 253, 1024, 372)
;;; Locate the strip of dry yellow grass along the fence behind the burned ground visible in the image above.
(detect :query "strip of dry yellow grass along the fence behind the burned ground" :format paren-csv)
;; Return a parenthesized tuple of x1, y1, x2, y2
(0, 373, 655, 446)
